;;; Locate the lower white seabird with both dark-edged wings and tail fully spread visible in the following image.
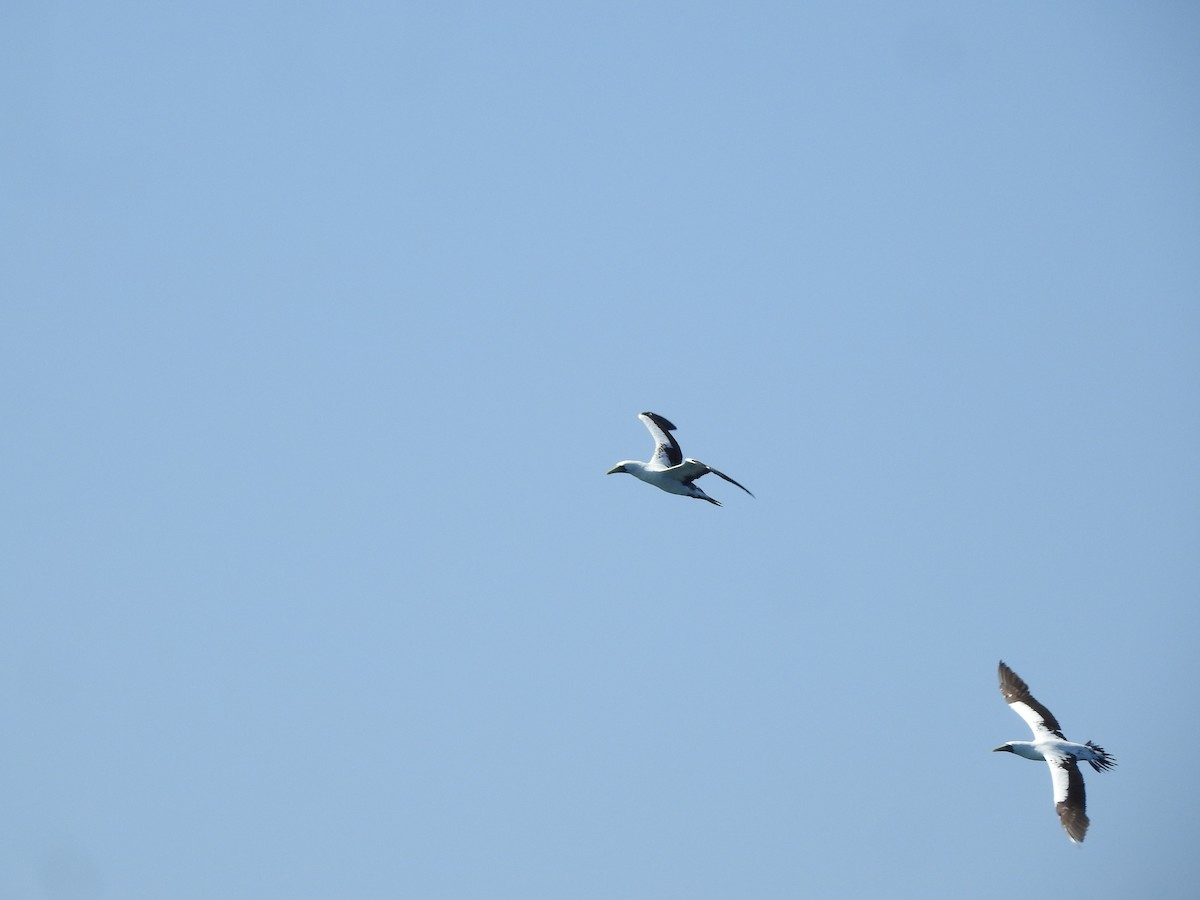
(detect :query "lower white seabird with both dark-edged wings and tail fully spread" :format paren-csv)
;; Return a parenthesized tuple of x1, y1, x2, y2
(992, 660, 1117, 844)
